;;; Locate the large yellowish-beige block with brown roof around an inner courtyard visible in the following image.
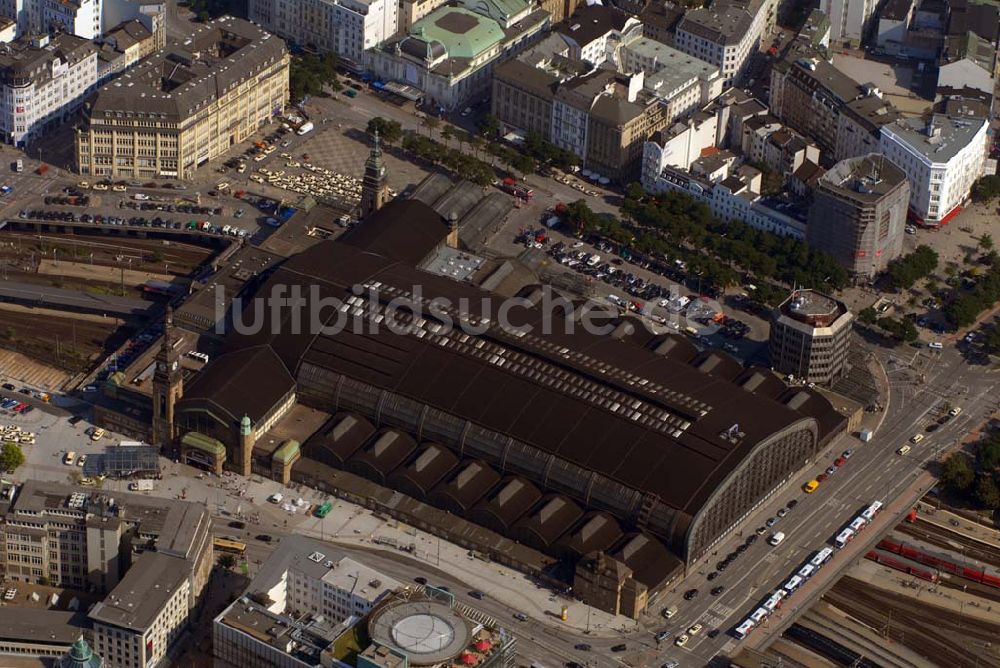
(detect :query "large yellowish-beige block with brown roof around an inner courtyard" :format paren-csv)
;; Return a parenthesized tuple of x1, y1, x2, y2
(76, 17, 289, 179)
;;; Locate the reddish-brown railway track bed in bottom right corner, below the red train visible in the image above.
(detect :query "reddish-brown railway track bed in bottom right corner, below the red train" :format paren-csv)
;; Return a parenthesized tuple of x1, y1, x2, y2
(824, 577, 1000, 668)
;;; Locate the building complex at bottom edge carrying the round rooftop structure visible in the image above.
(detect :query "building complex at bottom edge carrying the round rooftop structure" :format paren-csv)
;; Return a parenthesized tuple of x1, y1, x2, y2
(212, 536, 517, 668)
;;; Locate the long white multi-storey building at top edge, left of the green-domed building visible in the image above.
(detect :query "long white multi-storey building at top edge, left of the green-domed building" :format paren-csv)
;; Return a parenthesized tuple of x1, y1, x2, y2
(247, 0, 399, 68)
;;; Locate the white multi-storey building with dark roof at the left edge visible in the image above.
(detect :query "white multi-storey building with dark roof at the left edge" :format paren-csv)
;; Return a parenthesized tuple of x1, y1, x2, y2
(0, 34, 98, 146)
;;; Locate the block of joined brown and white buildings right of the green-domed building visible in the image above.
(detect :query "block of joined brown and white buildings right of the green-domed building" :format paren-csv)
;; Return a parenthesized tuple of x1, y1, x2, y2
(493, 6, 722, 181)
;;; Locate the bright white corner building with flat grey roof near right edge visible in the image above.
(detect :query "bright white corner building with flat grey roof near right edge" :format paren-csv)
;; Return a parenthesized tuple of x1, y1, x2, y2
(879, 114, 988, 226)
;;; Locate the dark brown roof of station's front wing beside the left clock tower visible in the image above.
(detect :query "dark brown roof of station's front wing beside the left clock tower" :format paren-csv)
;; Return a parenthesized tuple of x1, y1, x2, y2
(177, 346, 295, 424)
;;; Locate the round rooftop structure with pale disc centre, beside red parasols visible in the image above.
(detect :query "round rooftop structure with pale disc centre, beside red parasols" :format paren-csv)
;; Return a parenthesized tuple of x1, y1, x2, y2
(368, 601, 471, 666)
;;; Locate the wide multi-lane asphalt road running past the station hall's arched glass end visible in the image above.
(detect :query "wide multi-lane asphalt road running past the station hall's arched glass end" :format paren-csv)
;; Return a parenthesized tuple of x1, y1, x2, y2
(644, 345, 998, 665)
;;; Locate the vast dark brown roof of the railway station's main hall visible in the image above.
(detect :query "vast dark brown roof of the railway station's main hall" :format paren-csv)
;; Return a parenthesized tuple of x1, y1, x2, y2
(219, 202, 833, 514)
